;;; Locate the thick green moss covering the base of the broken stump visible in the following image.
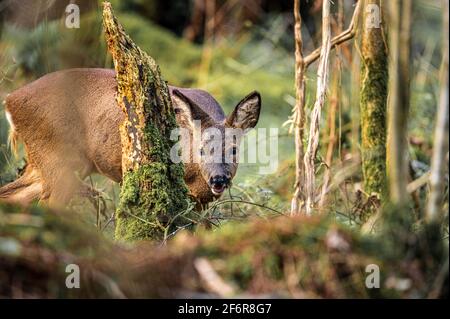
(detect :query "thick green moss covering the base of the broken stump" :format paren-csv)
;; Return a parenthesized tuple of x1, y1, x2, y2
(116, 154, 188, 241)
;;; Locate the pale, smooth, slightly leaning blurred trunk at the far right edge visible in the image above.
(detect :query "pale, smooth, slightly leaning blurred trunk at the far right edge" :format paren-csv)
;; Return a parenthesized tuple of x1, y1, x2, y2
(426, 0, 449, 222)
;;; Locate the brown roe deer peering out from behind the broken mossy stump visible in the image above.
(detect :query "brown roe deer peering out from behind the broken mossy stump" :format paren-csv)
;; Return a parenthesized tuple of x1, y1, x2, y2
(0, 69, 261, 206)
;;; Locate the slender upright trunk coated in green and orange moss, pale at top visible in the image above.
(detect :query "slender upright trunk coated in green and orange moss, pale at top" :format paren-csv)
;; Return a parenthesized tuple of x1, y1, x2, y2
(360, 0, 388, 196)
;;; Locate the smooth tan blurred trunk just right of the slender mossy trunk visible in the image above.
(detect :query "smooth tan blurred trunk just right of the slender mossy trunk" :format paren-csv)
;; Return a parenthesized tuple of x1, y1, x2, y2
(387, 0, 412, 204)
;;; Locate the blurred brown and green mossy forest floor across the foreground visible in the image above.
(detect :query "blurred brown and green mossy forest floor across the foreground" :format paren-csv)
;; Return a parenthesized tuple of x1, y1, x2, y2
(0, 205, 448, 298)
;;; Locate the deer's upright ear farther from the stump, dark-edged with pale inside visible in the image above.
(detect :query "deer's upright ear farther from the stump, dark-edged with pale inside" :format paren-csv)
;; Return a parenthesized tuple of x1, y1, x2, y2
(227, 91, 261, 130)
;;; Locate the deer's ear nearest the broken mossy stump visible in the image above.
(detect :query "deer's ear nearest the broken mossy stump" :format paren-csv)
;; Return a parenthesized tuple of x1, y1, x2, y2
(172, 90, 210, 127)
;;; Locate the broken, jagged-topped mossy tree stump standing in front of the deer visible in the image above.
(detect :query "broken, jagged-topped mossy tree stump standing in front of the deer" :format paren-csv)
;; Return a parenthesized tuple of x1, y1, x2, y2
(103, 2, 189, 240)
